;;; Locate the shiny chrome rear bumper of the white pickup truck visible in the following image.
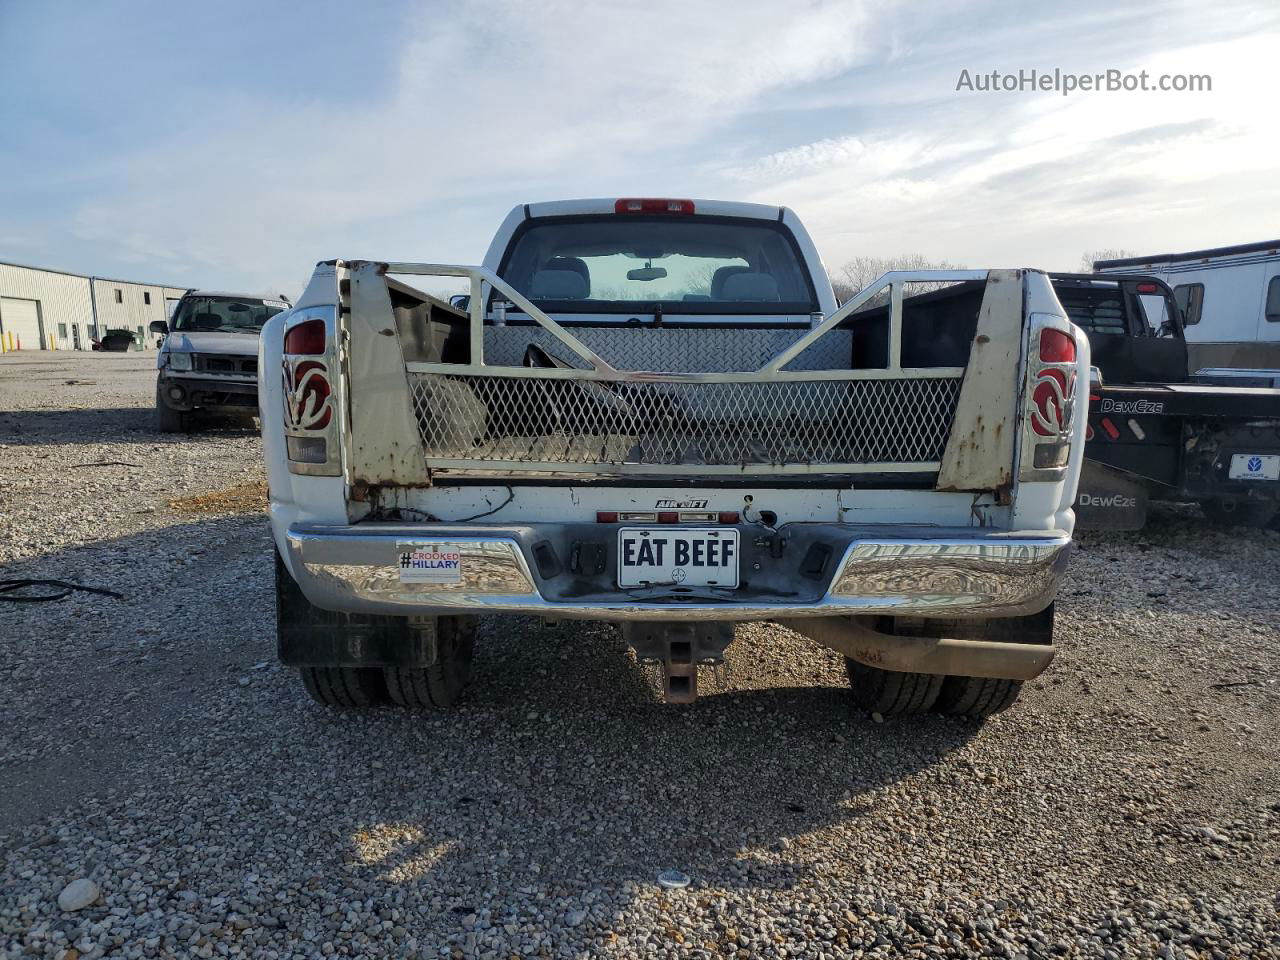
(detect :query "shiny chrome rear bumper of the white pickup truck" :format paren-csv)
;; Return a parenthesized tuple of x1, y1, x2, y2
(282, 524, 1070, 621)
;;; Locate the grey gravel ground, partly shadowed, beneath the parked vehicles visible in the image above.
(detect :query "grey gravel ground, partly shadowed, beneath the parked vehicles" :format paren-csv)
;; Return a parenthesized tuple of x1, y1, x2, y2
(0, 355, 1280, 957)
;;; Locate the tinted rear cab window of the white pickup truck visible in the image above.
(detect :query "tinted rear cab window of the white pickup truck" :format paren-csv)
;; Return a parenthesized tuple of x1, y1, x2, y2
(498, 214, 819, 323)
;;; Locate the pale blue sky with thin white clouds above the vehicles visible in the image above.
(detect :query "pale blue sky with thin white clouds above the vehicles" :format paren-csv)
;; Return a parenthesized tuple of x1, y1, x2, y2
(0, 0, 1280, 293)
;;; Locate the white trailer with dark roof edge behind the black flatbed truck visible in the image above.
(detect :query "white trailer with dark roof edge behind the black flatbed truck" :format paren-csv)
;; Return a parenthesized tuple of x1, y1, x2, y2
(1093, 239, 1280, 387)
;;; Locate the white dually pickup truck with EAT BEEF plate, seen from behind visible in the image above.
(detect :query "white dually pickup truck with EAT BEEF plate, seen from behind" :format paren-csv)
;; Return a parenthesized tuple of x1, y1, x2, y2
(260, 198, 1089, 717)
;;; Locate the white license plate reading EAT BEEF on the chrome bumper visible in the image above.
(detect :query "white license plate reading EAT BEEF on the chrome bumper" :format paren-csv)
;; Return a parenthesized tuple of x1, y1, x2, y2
(618, 527, 737, 588)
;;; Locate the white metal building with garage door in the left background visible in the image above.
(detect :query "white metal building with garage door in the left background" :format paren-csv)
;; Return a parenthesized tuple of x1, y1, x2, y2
(0, 262, 186, 352)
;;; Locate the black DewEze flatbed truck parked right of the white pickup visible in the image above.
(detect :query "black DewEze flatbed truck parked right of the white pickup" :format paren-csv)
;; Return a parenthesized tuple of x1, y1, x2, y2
(1051, 274, 1280, 530)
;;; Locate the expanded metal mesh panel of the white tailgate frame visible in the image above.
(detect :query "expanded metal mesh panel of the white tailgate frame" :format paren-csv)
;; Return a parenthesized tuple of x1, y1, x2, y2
(410, 372, 960, 467)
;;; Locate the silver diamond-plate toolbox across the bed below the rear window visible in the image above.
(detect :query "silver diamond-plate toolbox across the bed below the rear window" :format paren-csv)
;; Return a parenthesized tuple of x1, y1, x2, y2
(484, 326, 852, 374)
